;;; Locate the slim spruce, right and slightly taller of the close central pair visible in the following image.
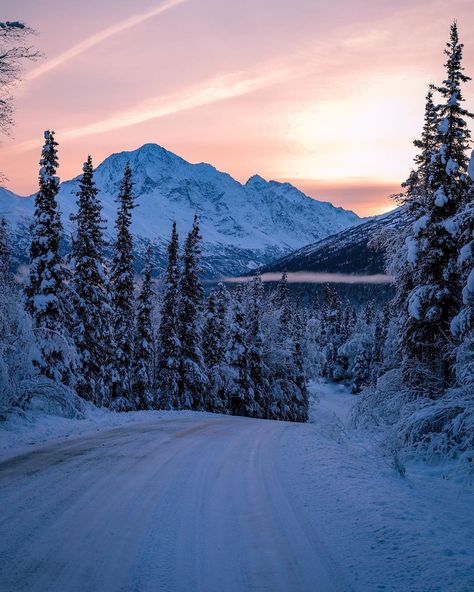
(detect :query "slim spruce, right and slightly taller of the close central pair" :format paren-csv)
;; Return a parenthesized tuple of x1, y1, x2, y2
(179, 215, 208, 410)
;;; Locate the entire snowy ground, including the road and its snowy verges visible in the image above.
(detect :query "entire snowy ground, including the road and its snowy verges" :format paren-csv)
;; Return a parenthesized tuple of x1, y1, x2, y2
(0, 384, 474, 592)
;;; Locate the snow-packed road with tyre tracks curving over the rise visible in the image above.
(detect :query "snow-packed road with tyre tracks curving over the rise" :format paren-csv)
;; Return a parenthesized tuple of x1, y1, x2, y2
(0, 416, 352, 592)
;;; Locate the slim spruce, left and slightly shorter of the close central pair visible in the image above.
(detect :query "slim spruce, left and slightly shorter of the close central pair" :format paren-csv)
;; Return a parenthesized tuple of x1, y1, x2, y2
(157, 222, 181, 409)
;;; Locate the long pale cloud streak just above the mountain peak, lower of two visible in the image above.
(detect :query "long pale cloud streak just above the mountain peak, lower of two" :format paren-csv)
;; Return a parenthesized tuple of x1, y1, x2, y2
(10, 68, 291, 152)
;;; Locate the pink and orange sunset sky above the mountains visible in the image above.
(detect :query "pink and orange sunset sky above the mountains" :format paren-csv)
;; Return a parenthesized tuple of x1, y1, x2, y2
(0, 0, 474, 215)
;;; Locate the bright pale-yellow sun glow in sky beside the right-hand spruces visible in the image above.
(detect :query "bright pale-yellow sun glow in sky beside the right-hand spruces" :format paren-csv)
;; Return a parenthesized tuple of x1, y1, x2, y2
(286, 76, 423, 182)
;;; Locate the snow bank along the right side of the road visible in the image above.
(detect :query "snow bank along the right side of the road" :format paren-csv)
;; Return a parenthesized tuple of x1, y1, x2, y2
(296, 376, 474, 592)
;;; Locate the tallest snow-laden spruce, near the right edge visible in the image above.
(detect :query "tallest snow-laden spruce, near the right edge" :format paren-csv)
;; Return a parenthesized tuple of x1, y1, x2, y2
(402, 22, 472, 397)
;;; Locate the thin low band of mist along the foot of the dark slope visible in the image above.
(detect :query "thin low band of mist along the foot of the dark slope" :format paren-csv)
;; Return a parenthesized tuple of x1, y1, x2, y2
(225, 271, 393, 284)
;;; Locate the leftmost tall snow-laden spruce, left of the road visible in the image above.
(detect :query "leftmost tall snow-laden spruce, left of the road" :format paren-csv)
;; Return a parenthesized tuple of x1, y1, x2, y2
(25, 131, 75, 384)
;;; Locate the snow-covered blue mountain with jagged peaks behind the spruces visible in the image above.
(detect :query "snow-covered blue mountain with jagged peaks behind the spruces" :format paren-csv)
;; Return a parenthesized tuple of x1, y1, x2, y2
(0, 144, 360, 277)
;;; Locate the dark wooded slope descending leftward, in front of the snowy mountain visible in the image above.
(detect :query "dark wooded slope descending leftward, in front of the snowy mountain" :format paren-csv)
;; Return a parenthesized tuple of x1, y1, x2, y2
(262, 208, 403, 274)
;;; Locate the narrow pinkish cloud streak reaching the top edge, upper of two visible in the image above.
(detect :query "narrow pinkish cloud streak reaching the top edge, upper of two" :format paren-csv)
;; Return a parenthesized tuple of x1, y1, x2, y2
(26, 0, 188, 80)
